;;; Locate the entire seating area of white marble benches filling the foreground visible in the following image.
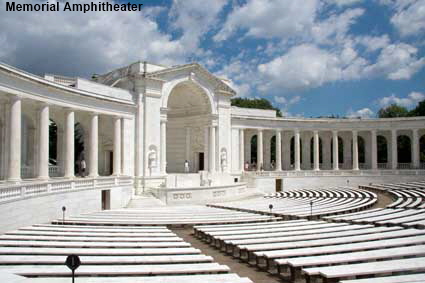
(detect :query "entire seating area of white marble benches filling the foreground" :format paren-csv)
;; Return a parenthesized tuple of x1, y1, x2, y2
(0, 182, 425, 283)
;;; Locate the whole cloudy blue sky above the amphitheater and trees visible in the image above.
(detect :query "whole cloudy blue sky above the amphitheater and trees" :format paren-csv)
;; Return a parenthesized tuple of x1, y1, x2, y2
(0, 0, 425, 117)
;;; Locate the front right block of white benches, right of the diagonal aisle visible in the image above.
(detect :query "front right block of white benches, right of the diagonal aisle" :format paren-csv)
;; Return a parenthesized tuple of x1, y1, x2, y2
(194, 222, 425, 283)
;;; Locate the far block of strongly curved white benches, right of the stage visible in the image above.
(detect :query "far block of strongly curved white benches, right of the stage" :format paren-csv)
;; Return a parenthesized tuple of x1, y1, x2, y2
(209, 187, 377, 219)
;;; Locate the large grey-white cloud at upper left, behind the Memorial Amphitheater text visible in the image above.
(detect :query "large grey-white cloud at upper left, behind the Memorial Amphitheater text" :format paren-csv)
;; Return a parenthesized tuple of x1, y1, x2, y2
(0, 0, 187, 75)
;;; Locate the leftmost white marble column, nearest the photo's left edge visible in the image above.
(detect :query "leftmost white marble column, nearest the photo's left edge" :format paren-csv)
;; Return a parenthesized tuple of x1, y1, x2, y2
(7, 96, 22, 182)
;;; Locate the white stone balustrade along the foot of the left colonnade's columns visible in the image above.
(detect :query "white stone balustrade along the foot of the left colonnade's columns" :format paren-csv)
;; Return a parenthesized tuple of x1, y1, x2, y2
(0, 176, 133, 203)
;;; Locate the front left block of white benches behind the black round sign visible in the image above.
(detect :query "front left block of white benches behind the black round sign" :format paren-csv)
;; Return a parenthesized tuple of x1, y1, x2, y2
(0, 224, 252, 283)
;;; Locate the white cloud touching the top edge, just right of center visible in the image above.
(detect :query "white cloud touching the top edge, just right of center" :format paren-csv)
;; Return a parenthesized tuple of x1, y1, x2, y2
(214, 0, 319, 41)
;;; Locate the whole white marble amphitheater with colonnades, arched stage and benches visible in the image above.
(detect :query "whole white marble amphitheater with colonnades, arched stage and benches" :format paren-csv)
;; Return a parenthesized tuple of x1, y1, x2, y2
(0, 62, 425, 283)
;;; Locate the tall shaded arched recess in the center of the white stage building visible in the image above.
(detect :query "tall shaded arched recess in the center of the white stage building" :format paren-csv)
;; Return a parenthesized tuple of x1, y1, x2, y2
(166, 80, 212, 173)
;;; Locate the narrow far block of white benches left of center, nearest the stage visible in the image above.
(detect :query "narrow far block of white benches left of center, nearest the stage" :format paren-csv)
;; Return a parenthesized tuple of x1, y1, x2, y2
(54, 205, 275, 226)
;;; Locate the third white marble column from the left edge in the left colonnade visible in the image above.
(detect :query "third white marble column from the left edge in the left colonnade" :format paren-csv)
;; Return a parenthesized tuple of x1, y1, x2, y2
(65, 110, 75, 178)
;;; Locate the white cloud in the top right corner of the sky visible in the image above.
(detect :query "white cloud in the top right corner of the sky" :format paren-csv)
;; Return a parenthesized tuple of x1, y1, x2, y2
(380, 0, 425, 36)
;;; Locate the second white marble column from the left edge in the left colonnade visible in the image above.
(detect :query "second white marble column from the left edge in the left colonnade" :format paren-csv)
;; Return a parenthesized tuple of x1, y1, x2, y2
(37, 104, 49, 180)
